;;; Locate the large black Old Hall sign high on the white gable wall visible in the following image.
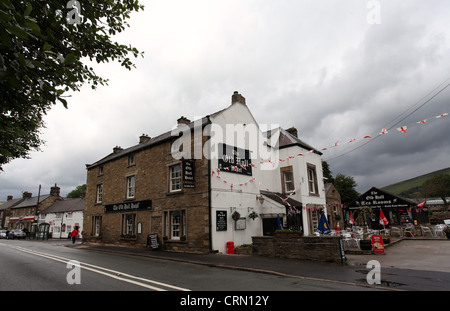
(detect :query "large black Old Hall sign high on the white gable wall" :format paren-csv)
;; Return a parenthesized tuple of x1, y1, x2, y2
(218, 143, 252, 176)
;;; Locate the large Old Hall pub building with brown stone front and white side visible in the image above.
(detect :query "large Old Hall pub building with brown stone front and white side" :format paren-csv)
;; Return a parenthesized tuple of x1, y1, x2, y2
(84, 92, 326, 252)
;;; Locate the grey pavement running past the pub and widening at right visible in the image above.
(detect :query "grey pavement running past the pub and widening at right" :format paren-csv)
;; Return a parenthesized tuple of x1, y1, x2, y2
(69, 239, 450, 290)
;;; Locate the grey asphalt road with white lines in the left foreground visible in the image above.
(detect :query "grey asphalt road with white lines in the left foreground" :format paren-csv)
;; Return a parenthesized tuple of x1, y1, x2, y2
(0, 240, 373, 292)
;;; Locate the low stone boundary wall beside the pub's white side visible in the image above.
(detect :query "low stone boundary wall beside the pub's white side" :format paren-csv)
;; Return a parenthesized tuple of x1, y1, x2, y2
(252, 236, 342, 263)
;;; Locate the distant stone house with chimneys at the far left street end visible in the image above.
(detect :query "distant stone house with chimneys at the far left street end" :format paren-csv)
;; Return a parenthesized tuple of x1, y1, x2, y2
(8, 184, 63, 232)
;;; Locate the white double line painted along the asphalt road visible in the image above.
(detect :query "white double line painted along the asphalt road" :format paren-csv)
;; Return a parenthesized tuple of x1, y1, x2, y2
(0, 243, 190, 291)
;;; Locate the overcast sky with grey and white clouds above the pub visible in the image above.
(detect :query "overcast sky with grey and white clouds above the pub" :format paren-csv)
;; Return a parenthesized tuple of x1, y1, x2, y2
(0, 0, 450, 200)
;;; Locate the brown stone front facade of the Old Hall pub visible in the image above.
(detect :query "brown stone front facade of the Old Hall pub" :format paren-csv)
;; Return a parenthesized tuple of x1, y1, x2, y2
(83, 134, 210, 252)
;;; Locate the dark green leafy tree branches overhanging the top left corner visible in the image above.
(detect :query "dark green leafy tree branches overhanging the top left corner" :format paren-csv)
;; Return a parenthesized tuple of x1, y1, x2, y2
(0, 0, 143, 170)
